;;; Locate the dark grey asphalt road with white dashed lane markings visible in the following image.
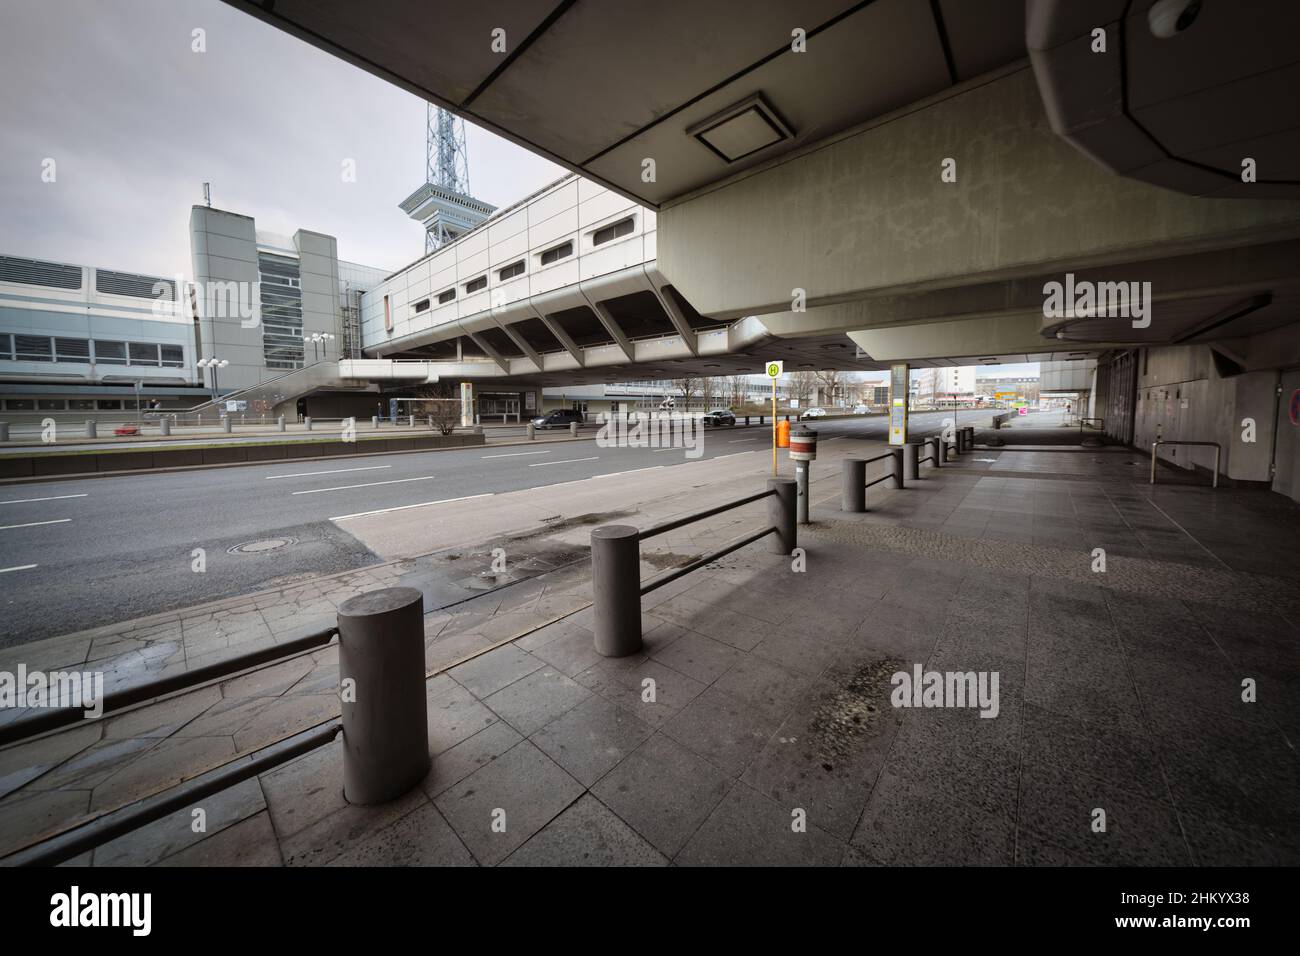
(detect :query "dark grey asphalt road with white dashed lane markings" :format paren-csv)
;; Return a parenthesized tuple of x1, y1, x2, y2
(0, 412, 989, 646)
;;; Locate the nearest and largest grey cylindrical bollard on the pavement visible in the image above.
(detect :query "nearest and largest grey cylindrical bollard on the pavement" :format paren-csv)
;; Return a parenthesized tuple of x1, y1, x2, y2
(338, 588, 430, 805)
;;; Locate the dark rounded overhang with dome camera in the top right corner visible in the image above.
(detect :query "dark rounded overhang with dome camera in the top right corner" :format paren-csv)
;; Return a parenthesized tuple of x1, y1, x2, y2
(1026, 0, 1300, 199)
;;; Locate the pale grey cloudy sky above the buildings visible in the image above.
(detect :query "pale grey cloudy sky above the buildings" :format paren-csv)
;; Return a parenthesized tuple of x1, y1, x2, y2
(0, 0, 563, 282)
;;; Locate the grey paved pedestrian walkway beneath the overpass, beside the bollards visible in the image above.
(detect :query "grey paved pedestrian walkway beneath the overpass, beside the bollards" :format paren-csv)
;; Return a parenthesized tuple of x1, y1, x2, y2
(0, 441, 1300, 865)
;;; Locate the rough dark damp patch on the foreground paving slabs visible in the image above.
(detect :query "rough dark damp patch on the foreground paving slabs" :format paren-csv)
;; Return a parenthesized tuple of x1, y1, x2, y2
(807, 658, 907, 773)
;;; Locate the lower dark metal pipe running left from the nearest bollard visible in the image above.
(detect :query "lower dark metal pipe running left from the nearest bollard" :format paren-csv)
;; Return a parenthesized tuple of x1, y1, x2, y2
(5, 721, 343, 866)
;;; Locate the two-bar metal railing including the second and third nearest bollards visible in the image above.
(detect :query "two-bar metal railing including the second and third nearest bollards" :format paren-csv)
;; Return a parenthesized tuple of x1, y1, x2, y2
(592, 477, 797, 657)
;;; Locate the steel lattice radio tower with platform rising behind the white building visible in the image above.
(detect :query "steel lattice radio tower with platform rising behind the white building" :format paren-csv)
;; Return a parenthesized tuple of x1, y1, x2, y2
(402, 103, 495, 254)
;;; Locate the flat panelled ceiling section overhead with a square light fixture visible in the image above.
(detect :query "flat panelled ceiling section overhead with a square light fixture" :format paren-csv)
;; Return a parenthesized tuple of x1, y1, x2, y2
(226, 0, 1026, 207)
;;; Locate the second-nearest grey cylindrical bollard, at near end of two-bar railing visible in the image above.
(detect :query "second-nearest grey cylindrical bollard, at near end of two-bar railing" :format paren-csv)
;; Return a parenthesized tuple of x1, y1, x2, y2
(592, 524, 641, 657)
